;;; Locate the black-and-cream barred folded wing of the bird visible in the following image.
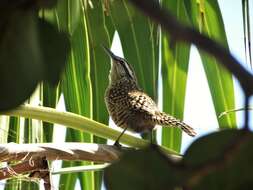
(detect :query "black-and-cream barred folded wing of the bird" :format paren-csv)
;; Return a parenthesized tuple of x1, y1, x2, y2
(128, 91, 159, 115)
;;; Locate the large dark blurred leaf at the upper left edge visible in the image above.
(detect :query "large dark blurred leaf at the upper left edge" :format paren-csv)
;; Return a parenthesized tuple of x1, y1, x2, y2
(0, 11, 69, 110)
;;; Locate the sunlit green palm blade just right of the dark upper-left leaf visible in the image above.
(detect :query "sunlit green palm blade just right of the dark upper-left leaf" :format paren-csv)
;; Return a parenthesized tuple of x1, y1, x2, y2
(53, 1, 94, 189)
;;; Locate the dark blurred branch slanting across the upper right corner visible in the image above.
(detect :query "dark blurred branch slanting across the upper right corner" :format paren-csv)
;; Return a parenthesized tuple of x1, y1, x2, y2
(130, 0, 253, 96)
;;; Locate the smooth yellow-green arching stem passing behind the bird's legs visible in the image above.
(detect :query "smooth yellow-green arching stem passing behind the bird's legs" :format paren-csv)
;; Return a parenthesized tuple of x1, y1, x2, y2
(0, 104, 178, 155)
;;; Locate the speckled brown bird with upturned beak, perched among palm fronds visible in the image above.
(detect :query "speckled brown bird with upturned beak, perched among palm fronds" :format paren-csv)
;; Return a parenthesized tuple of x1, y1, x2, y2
(102, 45, 196, 145)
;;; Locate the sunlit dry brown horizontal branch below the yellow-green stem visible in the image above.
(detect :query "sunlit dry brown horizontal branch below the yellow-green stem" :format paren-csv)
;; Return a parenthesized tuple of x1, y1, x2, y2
(0, 143, 120, 162)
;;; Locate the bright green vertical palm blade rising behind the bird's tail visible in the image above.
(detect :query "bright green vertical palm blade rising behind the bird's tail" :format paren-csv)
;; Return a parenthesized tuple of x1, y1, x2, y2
(161, 0, 190, 152)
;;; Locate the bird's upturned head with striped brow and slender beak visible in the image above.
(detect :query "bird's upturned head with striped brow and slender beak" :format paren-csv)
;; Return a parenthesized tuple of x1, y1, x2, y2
(102, 46, 137, 83)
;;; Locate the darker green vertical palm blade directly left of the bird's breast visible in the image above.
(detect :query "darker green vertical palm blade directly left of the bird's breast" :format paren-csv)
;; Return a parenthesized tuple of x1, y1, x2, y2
(85, 4, 114, 190)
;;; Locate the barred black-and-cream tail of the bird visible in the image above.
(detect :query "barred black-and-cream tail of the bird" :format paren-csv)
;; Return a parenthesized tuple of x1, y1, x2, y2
(152, 112, 197, 137)
